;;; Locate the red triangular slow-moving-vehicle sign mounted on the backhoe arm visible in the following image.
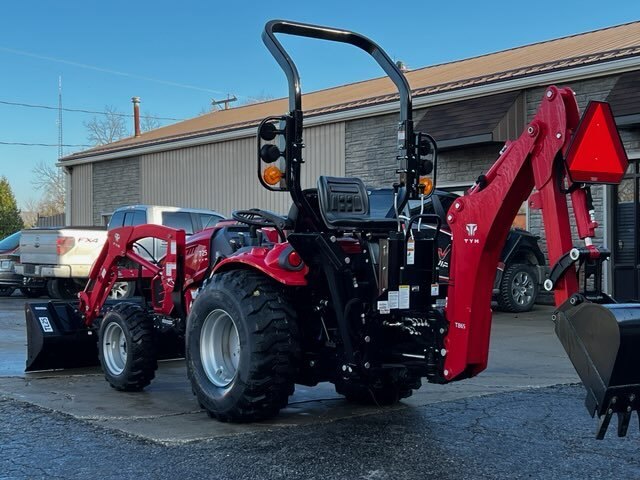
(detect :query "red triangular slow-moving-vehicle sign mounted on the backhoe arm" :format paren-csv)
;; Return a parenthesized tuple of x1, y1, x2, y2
(567, 102, 629, 183)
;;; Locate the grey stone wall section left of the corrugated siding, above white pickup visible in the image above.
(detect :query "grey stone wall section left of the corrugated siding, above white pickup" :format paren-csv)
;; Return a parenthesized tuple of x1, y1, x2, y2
(93, 157, 140, 225)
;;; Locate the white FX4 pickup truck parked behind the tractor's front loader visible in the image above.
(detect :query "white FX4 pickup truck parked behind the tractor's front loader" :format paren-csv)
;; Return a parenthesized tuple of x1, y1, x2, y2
(15, 205, 224, 299)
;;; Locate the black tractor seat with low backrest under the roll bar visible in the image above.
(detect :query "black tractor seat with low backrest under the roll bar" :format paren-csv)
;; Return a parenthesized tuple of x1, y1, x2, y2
(318, 176, 398, 231)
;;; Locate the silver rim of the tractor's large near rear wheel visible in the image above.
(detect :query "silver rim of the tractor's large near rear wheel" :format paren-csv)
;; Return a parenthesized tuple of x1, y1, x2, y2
(200, 309, 240, 388)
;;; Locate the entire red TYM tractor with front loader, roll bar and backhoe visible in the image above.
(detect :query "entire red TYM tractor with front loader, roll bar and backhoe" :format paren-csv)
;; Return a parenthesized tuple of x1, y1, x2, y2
(26, 20, 640, 438)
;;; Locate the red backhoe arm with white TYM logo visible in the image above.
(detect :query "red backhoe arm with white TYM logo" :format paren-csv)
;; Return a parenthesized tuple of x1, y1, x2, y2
(444, 87, 626, 380)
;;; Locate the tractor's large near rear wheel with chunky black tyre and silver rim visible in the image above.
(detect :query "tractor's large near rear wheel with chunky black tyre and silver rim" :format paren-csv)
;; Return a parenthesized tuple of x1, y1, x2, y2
(186, 270, 300, 422)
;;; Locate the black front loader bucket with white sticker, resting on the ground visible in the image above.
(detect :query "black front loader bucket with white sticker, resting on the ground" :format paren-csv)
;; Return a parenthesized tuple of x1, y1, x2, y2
(25, 302, 99, 372)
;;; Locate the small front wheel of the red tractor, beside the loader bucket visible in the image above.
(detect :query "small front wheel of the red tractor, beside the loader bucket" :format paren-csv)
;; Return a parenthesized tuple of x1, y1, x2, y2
(98, 303, 158, 392)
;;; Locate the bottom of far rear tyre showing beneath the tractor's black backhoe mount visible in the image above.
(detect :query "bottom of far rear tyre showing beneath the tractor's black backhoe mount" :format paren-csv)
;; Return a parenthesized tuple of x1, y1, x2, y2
(335, 378, 422, 406)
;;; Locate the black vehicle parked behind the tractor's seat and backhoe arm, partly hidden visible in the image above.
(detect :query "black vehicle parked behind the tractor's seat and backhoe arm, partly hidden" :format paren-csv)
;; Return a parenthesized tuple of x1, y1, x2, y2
(369, 188, 547, 313)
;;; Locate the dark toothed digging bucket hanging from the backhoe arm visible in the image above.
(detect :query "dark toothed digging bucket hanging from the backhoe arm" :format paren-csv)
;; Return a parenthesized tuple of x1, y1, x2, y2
(555, 302, 640, 439)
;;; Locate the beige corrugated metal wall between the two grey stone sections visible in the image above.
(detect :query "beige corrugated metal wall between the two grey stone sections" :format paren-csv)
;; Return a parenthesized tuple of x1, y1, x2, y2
(140, 122, 345, 215)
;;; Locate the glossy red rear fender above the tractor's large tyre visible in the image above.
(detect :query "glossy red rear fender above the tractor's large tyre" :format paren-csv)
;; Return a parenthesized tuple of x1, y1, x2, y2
(212, 243, 309, 287)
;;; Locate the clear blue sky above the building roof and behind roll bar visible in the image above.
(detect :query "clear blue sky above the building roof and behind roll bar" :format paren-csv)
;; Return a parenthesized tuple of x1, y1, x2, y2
(0, 0, 640, 210)
